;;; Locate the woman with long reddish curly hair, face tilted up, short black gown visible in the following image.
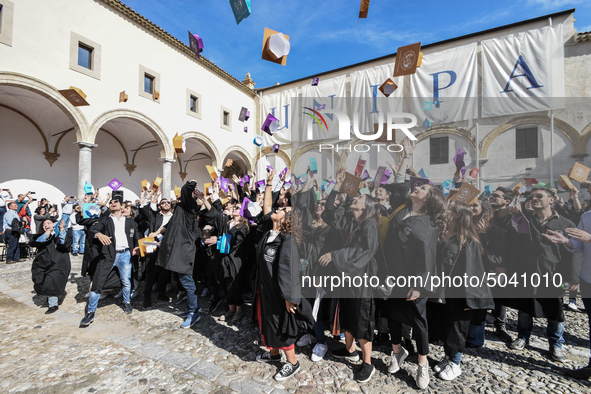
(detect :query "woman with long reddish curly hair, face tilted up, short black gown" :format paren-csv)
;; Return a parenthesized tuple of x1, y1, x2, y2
(384, 184, 446, 389)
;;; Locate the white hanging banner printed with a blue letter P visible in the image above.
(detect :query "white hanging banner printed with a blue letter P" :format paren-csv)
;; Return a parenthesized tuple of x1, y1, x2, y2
(410, 43, 478, 126)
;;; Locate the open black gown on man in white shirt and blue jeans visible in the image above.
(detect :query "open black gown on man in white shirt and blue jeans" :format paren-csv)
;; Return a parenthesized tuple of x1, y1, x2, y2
(89, 215, 139, 293)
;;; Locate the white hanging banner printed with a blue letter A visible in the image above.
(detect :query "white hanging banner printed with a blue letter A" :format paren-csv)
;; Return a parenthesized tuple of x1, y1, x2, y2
(481, 24, 565, 117)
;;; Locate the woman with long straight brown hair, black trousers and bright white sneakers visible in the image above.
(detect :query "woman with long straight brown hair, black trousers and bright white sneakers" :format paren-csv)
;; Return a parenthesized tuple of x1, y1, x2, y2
(434, 201, 494, 380)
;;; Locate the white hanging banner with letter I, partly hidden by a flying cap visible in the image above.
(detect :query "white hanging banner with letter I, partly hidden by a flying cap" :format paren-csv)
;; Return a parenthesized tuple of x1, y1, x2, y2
(349, 63, 404, 134)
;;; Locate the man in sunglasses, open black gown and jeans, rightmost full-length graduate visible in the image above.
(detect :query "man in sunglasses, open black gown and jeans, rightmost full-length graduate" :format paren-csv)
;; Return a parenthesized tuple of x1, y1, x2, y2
(505, 187, 575, 362)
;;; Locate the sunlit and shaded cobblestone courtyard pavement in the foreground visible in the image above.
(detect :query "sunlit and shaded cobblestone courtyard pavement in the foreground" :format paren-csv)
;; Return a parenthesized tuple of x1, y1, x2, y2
(0, 258, 591, 394)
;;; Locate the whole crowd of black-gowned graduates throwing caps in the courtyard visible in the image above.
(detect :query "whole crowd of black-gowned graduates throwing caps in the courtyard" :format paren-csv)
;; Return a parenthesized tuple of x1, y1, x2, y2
(20, 141, 591, 388)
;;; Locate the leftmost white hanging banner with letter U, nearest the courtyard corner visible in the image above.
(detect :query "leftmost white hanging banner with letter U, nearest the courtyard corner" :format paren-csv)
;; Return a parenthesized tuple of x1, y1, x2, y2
(264, 88, 298, 147)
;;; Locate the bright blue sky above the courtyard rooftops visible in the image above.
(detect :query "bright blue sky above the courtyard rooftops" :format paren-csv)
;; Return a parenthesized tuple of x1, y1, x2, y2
(123, 0, 591, 88)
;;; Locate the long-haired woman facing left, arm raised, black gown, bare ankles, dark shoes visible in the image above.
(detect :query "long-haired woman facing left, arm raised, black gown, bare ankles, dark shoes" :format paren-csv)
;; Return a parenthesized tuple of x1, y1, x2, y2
(318, 169, 381, 382)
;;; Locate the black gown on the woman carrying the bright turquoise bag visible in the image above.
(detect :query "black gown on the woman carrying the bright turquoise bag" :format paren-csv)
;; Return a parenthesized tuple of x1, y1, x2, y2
(204, 207, 248, 299)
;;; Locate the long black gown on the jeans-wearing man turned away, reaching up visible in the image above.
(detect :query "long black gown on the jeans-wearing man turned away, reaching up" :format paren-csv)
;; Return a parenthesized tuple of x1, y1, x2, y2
(156, 182, 201, 275)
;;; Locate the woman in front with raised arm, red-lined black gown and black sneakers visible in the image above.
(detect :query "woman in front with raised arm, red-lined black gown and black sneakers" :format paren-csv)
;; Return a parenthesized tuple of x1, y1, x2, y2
(253, 171, 314, 382)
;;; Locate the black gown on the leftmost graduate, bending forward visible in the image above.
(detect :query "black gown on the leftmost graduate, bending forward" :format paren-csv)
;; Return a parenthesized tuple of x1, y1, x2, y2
(31, 232, 72, 296)
